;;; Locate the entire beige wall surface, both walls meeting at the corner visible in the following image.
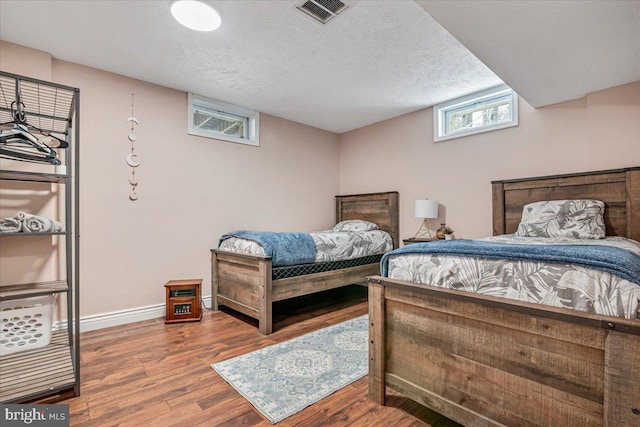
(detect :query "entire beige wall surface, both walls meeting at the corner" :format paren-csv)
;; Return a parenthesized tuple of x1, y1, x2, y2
(0, 42, 640, 326)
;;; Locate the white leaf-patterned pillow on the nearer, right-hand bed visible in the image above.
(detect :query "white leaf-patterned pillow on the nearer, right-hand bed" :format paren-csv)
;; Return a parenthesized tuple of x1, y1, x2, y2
(516, 199, 606, 239)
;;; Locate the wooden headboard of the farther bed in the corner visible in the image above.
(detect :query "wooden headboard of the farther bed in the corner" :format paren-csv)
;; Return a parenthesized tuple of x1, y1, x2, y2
(336, 191, 400, 248)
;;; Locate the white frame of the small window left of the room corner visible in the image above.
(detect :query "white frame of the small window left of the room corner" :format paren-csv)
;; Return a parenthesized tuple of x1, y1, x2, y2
(188, 93, 260, 147)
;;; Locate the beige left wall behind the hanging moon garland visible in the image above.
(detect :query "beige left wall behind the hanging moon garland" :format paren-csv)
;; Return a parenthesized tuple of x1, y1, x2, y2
(0, 44, 339, 316)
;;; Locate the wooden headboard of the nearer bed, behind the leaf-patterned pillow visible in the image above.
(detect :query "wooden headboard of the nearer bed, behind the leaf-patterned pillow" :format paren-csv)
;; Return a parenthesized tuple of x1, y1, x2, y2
(491, 166, 640, 241)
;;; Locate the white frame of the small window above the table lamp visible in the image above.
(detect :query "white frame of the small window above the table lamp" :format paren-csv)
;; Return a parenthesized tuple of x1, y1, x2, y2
(433, 85, 518, 142)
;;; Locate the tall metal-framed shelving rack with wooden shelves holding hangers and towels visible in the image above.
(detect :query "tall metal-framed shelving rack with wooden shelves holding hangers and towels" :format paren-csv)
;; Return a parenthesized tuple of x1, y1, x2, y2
(0, 71, 80, 403)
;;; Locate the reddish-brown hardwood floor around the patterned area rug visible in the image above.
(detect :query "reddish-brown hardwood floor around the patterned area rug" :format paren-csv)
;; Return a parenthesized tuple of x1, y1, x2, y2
(61, 286, 457, 427)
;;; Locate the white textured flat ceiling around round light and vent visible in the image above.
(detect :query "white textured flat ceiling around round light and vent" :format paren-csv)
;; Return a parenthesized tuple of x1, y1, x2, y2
(0, 0, 501, 133)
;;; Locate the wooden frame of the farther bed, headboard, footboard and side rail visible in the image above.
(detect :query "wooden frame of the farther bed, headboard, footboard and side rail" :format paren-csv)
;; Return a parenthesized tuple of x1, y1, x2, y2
(211, 191, 400, 335)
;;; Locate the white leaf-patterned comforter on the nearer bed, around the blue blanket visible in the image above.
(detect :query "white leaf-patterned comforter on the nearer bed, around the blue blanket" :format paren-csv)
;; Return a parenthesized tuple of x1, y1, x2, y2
(388, 235, 640, 319)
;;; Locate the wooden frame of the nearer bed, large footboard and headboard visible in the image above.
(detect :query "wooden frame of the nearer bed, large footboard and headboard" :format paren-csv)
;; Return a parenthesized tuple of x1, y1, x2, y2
(369, 167, 640, 427)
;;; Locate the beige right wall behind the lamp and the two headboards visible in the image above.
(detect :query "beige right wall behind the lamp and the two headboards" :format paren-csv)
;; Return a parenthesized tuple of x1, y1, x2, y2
(340, 82, 640, 238)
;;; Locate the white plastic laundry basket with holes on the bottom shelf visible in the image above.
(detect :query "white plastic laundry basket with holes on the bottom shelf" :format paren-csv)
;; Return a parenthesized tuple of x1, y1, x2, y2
(0, 294, 56, 356)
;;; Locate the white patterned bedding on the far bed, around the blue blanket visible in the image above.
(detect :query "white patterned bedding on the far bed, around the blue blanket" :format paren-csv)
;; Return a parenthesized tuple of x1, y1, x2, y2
(219, 230, 393, 262)
